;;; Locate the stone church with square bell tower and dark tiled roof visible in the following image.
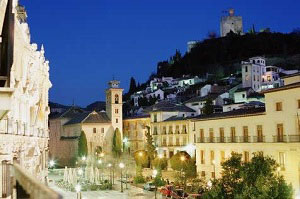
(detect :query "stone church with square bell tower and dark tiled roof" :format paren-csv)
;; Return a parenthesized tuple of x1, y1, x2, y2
(49, 80, 123, 166)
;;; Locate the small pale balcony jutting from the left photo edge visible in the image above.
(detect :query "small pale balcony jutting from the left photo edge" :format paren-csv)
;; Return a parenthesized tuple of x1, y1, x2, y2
(0, 87, 14, 120)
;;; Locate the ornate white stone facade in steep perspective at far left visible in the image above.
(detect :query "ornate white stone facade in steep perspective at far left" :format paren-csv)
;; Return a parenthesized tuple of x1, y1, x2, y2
(0, 0, 56, 198)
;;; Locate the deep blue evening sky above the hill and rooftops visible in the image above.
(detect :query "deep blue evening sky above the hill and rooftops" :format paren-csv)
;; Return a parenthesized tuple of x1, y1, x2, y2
(21, 0, 300, 106)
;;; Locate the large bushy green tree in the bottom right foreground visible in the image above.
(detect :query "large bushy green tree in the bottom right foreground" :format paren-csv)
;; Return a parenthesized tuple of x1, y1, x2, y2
(203, 153, 293, 199)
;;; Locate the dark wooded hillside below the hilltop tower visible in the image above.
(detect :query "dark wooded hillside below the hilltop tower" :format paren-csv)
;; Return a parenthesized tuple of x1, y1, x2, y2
(157, 32, 300, 77)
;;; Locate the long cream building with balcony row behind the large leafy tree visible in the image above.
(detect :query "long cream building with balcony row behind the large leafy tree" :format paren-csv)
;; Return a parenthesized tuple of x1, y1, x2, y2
(190, 82, 300, 194)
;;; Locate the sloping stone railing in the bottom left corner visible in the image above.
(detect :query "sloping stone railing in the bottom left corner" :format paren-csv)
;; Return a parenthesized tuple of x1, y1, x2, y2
(12, 164, 62, 199)
